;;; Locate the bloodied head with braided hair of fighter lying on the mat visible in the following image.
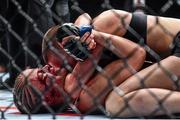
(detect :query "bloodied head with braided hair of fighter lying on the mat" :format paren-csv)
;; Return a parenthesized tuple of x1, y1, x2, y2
(14, 65, 69, 113)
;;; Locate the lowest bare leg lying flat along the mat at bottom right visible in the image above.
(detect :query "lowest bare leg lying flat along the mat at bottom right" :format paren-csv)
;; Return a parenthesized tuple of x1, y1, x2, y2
(106, 88, 180, 117)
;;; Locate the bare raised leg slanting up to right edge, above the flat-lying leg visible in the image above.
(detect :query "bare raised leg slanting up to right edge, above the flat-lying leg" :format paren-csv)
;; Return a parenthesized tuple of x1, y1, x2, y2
(106, 56, 180, 114)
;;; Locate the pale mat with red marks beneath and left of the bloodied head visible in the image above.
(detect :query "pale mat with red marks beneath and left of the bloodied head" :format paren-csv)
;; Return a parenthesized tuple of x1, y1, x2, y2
(0, 90, 114, 120)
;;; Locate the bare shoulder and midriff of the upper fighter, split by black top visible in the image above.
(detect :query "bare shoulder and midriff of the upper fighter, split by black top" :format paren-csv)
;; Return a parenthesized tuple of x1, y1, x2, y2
(93, 10, 180, 53)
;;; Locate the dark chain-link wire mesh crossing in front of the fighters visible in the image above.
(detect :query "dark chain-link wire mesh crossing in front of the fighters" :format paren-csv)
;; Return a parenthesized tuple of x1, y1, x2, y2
(0, 0, 179, 119)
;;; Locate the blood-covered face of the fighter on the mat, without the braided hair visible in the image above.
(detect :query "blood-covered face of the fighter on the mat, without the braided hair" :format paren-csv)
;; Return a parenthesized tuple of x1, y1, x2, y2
(24, 65, 65, 105)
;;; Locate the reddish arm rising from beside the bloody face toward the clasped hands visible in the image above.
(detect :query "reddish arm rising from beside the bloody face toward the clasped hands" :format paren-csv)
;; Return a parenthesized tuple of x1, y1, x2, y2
(64, 46, 102, 99)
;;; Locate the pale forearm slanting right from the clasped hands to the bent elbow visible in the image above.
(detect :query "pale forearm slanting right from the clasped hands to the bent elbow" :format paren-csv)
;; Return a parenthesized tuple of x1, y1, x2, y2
(94, 31, 145, 58)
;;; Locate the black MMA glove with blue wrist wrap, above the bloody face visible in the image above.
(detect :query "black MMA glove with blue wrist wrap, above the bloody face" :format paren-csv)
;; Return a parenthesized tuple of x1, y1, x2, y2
(56, 23, 92, 61)
